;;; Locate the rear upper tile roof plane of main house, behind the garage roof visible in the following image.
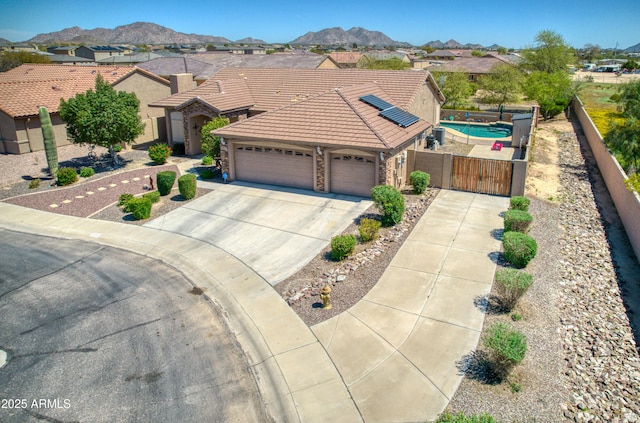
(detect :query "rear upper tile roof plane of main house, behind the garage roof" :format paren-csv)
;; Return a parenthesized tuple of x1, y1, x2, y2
(212, 68, 429, 111)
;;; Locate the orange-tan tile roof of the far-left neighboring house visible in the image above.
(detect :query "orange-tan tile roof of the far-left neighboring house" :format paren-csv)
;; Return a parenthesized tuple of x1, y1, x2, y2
(0, 64, 169, 118)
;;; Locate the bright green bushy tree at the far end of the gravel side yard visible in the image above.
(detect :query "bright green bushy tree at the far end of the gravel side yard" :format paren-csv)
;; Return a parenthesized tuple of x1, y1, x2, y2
(524, 71, 575, 119)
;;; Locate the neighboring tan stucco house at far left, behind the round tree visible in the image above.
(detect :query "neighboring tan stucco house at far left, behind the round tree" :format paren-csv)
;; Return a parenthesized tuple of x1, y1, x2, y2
(0, 64, 171, 154)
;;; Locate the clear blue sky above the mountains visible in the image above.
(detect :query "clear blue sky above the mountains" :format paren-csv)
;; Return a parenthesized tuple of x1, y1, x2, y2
(0, 0, 640, 49)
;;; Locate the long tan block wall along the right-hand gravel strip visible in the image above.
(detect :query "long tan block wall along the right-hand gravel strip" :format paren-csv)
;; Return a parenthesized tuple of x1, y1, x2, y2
(573, 97, 640, 260)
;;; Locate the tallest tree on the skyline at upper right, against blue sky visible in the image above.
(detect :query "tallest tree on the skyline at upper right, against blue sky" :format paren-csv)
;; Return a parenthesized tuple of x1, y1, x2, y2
(522, 30, 575, 73)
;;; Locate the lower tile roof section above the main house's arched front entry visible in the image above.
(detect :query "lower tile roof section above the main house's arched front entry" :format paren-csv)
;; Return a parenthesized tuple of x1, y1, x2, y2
(149, 79, 255, 113)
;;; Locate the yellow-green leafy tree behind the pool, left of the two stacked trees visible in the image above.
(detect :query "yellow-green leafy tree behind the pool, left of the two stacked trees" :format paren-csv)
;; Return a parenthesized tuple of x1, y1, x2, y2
(478, 63, 524, 107)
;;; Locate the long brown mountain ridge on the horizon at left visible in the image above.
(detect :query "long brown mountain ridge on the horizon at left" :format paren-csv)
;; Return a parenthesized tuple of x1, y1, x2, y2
(28, 22, 231, 44)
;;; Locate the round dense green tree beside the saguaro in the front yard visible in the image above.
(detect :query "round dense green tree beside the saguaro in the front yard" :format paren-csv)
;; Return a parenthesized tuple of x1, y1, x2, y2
(59, 75, 144, 166)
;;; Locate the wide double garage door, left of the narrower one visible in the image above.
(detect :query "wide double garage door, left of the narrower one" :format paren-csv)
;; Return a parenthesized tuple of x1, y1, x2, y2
(234, 145, 314, 189)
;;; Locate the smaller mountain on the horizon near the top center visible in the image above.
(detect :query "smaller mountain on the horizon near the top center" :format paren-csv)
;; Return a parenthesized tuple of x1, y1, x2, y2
(290, 27, 411, 47)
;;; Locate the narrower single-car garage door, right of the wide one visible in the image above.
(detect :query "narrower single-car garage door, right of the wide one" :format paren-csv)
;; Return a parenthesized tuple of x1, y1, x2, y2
(331, 154, 376, 197)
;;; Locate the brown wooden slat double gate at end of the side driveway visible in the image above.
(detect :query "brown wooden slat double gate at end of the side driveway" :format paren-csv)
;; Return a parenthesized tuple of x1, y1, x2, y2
(451, 156, 513, 196)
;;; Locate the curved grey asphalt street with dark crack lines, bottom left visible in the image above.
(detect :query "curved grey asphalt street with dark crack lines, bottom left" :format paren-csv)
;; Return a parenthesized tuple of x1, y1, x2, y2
(0, 230, 265, 422)
